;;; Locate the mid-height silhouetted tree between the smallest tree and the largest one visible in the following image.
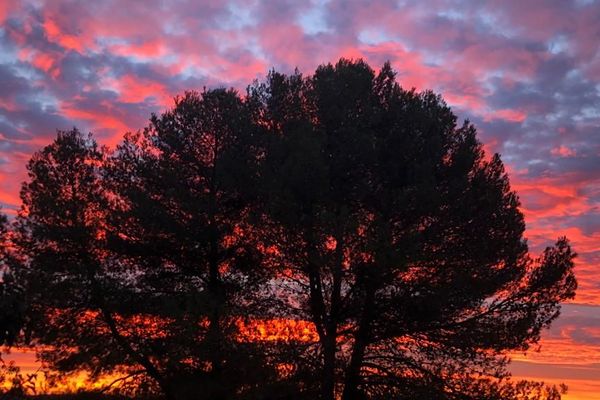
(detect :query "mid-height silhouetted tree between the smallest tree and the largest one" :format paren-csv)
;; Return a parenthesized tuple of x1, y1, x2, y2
(107, 89, 282, 399)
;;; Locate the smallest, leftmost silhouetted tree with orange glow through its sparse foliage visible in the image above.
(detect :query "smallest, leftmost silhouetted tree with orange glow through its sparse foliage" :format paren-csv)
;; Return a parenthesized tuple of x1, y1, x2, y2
(14, 129, 172, 396)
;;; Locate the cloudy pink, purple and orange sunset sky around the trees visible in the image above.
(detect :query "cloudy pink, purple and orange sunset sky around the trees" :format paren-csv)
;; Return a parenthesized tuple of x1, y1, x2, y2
(0, 0, 600, 400)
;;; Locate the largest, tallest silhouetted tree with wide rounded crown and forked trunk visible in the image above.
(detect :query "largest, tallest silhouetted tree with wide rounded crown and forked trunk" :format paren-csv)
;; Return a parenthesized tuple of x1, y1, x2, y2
(251, 60, 576, 399)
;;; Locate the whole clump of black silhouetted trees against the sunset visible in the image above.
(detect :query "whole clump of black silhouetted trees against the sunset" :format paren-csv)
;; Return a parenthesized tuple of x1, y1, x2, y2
(0, 59, 576, 400)
